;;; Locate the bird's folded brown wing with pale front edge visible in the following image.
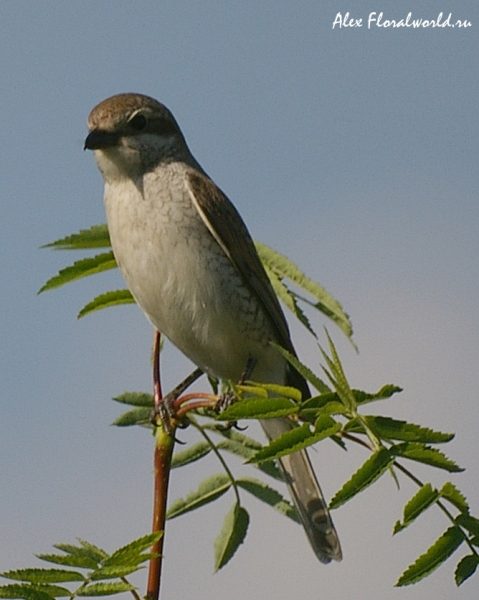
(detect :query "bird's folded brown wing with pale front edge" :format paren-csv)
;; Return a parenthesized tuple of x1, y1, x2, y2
(187, 171, 294, 352)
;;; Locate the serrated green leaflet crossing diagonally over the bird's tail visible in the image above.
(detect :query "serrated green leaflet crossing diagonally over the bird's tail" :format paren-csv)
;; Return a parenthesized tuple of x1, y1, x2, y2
(248, 415, 341, 463)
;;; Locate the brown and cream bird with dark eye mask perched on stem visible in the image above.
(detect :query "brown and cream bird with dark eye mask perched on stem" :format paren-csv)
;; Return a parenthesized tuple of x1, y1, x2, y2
(84, 93, 342, 563)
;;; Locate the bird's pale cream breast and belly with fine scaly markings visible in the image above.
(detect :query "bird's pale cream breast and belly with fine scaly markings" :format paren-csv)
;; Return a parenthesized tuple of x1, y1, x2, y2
(105, 169, 285, 382)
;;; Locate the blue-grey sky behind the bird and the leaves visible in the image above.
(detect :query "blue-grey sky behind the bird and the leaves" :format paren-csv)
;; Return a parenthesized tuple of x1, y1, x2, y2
(0, 0, 479, 600)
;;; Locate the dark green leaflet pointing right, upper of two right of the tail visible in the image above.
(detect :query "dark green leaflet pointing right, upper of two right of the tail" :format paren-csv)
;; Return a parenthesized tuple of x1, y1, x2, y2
(346, 415, 454, 444)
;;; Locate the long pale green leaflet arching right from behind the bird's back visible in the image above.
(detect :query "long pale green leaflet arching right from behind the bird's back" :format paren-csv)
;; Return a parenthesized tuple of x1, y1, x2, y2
(255, 242, 353, 341)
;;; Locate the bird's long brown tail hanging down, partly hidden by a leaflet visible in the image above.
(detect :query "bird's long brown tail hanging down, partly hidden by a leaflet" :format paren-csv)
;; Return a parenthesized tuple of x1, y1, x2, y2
(261, 419, 342, 563)
